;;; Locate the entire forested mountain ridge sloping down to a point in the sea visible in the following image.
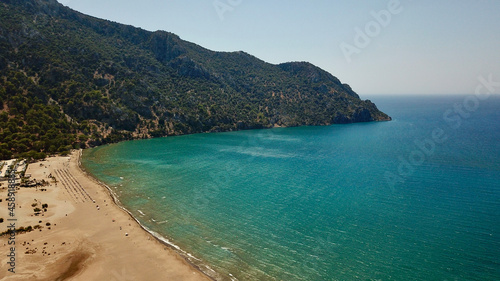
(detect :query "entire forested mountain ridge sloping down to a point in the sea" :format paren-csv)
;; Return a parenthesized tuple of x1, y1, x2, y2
(0, 0, 389, 159)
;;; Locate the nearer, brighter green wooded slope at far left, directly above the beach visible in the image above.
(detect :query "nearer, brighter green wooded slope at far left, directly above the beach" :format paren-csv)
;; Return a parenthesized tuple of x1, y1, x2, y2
(0, 71, 81, 159)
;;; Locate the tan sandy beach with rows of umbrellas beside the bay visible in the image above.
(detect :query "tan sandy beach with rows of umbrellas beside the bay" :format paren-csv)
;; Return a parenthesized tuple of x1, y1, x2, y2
(0, 151, 210, 281)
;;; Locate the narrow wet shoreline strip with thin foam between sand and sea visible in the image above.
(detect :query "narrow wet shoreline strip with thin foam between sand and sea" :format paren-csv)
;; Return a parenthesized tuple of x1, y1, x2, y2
(76, 149, 217, 281)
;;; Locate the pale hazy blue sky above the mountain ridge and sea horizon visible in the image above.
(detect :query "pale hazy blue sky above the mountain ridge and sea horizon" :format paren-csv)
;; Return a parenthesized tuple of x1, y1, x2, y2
(58, 0, 500, 96)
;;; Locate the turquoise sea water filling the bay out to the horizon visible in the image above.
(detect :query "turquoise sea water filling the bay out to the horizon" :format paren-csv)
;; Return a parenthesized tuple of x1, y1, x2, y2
(83, 96, 500, 280)
